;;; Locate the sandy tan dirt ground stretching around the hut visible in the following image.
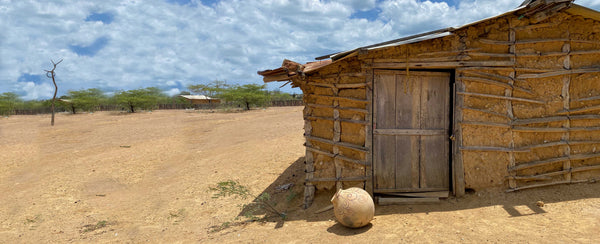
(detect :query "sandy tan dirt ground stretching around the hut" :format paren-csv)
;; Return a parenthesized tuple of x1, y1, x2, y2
(0, 107, 600, 243)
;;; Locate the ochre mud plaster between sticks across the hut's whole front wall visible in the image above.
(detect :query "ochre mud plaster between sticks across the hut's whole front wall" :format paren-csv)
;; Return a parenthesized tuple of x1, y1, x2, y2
(302, 10, 600, 194)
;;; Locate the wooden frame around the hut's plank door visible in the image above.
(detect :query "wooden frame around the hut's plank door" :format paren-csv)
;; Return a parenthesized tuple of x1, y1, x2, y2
(367, 69, 465, 196)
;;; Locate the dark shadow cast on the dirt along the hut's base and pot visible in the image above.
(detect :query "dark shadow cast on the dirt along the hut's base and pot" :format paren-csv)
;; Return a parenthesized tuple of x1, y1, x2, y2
(239, 157, 600, 235)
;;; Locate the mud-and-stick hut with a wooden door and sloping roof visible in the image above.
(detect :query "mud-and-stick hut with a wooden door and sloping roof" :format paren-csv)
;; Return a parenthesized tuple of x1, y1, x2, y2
(258, 0, 600, 207)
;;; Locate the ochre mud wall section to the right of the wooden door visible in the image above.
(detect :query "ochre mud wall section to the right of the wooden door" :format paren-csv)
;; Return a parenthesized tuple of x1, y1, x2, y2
(456, 14, 600, 190)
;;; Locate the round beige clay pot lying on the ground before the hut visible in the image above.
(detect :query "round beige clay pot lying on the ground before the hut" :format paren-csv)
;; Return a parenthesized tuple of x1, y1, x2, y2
(331, 187, 375, 228)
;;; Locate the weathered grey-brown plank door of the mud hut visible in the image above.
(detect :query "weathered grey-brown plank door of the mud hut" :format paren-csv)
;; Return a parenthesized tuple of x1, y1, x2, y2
(373, 70, 450, 193)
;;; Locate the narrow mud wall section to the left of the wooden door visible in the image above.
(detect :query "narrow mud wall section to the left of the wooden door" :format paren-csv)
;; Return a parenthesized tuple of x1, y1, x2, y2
(299, 57, 368, 191)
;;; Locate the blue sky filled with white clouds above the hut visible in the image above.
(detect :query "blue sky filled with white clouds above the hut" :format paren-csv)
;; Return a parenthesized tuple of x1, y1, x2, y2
(0, 0, 600, 99)
